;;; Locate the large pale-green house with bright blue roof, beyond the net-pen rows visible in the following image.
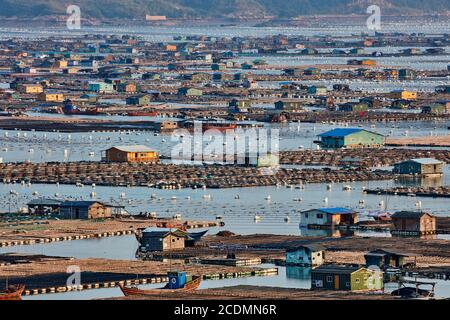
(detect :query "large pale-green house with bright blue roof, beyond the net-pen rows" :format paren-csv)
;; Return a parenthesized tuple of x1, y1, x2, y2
(316, 128, 385, 149)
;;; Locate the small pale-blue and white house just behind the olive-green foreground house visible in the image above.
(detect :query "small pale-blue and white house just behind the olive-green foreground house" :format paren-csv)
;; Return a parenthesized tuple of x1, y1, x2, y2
(286, 244, 325, 266)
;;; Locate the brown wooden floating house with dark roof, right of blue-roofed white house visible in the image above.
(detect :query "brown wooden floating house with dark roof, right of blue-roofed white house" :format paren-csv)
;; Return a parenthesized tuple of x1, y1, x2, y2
(391, 211, 436, 235)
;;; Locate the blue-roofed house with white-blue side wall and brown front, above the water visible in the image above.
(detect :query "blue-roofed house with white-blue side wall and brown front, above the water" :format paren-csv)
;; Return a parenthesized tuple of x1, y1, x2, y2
(300, 207, 358, 227)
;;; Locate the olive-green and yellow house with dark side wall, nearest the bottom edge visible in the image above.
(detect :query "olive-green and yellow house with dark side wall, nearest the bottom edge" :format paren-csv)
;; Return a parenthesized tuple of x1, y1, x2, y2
(311, 265, 384, 291)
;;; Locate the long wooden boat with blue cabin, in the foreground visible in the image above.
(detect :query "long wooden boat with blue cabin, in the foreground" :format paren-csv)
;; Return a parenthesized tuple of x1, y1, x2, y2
(119, 272, 202, 297)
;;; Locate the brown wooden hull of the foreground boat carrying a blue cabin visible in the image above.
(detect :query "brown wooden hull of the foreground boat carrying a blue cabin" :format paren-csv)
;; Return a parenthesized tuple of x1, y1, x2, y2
(119, 276, 202, 297)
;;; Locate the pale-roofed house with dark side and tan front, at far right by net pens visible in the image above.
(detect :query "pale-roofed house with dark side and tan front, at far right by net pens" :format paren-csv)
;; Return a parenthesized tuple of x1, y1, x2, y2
(393, 158, 444, 176)
